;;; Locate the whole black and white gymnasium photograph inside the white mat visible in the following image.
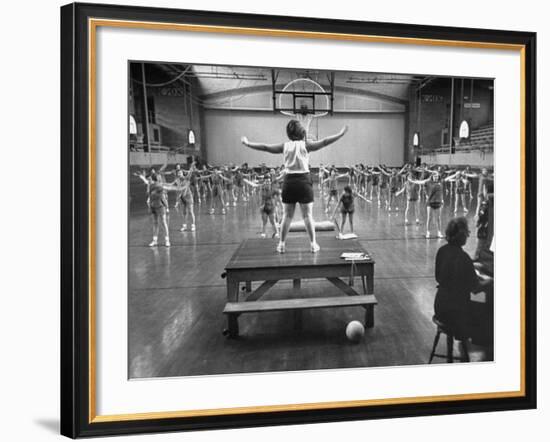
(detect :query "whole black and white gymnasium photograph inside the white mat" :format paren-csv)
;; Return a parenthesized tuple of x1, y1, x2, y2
(127, 60, 496, 379)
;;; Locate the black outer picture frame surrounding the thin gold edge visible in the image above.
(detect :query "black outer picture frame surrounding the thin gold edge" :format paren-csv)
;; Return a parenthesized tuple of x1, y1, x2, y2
(61, 3, 537, 438)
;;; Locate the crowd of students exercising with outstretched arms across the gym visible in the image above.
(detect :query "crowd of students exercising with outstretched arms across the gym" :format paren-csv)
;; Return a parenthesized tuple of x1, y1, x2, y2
(136, 163, 493, 258)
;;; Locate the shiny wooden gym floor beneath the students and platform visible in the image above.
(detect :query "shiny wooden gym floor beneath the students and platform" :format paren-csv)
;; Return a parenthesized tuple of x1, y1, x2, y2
(128, 179, 492, 378)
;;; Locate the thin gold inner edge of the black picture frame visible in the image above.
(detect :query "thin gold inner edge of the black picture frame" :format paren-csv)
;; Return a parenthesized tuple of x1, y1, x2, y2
(88, 18, 526, 423)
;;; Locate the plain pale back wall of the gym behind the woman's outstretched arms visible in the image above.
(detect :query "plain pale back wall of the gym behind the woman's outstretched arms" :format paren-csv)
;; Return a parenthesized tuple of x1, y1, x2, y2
(202, 109, 406, 167)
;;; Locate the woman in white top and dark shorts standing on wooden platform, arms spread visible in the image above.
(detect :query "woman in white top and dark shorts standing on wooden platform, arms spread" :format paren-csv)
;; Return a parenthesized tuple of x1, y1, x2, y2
(241, 120, 348, 253)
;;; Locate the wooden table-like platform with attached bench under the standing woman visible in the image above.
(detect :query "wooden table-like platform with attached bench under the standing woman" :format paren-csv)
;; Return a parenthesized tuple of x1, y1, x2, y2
(223, 236, 377, 337)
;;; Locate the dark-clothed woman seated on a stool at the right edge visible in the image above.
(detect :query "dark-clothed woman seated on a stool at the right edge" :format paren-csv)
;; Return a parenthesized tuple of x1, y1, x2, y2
(434, 217, 492, 341)
